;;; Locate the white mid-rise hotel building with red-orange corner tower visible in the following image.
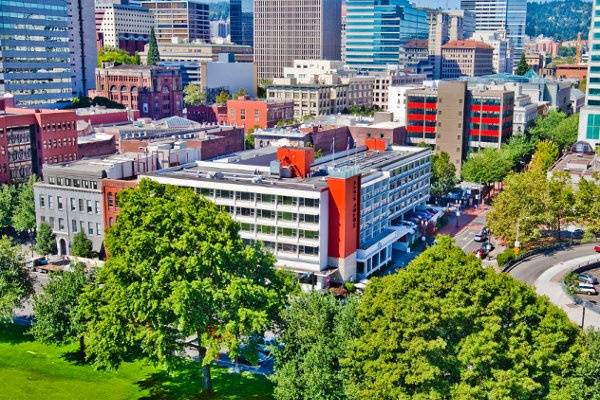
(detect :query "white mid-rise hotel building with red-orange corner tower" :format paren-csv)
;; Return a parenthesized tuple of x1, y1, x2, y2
(137, 144, 431, 287)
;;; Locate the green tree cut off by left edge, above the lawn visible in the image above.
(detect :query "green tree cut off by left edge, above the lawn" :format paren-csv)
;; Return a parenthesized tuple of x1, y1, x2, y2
(0, 236, 33, 321)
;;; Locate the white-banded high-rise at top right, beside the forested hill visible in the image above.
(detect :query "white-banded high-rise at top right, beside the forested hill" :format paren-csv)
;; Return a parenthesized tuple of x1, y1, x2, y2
(460, 0, 527, 70)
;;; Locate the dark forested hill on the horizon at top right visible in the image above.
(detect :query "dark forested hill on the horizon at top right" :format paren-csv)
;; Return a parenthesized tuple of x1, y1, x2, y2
(525, 0, 592, 40)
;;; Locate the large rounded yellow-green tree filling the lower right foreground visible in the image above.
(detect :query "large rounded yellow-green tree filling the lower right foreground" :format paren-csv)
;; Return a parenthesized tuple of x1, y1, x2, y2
(343, 236, 583, 400)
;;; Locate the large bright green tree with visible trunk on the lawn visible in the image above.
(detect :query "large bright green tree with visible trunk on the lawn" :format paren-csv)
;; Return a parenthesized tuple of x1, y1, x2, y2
(83, 180, 297, 392)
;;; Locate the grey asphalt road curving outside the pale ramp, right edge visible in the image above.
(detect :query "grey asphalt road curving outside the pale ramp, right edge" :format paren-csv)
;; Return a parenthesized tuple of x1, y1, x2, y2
(509, 244, 596, 285)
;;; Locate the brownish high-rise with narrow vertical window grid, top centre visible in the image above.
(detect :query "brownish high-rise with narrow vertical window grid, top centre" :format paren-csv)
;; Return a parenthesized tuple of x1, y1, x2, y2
(254, 0, 341, 80)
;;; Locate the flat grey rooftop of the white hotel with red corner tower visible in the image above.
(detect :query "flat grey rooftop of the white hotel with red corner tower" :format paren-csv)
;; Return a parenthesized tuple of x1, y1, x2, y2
(144, 146, 430, 191)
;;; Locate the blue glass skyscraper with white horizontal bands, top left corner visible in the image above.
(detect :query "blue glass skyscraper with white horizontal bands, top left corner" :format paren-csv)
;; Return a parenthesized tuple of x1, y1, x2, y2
(0, 0, 74, 107)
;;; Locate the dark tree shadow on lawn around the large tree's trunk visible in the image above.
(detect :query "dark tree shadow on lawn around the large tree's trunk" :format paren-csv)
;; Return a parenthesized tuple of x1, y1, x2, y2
(137, 362, 272, 400)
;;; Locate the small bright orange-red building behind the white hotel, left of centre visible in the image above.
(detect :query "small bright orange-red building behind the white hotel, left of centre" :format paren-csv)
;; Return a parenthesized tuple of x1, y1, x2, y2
(227, 97, 294, 133)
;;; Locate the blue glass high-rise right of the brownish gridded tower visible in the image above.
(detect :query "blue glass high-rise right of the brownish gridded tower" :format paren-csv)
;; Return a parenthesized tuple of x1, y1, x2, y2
(344, 0, 428, 71)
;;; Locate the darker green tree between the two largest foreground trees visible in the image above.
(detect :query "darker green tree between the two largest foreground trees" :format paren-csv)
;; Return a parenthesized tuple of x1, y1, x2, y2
(273, 291, 358, 400)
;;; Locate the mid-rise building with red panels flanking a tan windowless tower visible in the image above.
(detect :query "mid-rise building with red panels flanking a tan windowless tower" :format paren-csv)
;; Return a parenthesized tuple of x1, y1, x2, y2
(406, 81, 514, 171)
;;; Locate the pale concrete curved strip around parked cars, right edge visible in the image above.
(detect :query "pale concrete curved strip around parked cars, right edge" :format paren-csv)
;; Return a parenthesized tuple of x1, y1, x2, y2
(534, 254, 600, 328)
